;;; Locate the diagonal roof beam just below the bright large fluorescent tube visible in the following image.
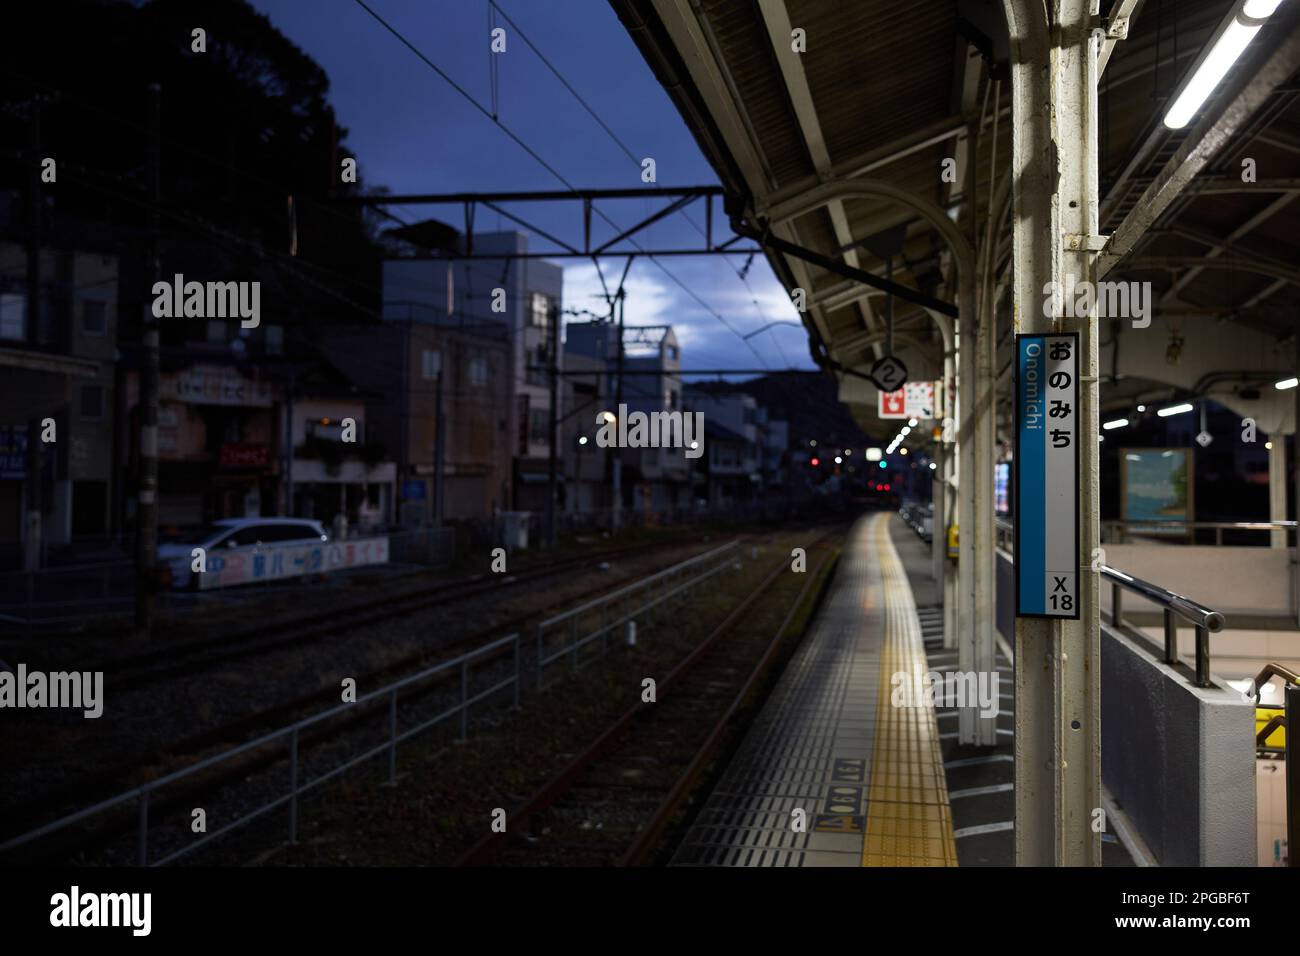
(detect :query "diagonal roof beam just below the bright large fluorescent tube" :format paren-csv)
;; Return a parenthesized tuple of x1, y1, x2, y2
(1097, 8, 1300, 278)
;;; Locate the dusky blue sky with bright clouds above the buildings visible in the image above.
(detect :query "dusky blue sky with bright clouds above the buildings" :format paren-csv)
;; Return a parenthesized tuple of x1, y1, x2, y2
(251, 0, 811, 368)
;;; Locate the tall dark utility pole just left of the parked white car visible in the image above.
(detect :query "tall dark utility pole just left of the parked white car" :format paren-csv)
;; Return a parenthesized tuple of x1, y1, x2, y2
(135, 83, 163, 637)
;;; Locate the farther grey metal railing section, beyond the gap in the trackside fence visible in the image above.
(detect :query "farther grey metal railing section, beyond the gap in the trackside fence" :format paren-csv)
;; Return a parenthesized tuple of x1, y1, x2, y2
(536, 541, 738, 689)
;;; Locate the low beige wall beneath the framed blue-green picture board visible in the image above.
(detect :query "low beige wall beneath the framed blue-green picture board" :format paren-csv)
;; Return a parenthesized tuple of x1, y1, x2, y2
(1101, 544, 1295, 627)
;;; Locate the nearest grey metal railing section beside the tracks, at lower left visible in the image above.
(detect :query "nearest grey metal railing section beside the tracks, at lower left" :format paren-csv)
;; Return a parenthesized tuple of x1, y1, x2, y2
(0, 633, 523, 866)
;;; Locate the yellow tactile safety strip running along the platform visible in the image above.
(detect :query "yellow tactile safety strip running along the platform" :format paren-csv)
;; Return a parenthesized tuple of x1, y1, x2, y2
(862, 515, 957, 866)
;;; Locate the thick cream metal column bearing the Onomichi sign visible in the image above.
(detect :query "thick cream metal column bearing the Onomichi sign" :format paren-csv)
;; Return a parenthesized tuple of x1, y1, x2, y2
(1004, 0, 1101, 866)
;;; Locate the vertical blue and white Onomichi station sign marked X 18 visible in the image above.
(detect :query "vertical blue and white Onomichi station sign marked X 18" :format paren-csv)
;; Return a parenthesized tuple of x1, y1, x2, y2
(1015, 332, 1080, 619)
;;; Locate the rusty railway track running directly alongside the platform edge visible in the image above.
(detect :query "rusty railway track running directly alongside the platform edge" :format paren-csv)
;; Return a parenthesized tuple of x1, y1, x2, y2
(456, 533, 833, 866)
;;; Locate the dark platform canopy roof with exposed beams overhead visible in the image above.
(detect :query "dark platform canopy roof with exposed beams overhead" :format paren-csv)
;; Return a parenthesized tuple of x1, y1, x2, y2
(611, 0, 1300, 433)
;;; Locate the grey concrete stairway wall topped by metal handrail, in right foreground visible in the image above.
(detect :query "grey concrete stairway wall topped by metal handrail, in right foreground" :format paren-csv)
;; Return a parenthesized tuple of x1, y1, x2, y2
(1101, 627, 1257, 866)
